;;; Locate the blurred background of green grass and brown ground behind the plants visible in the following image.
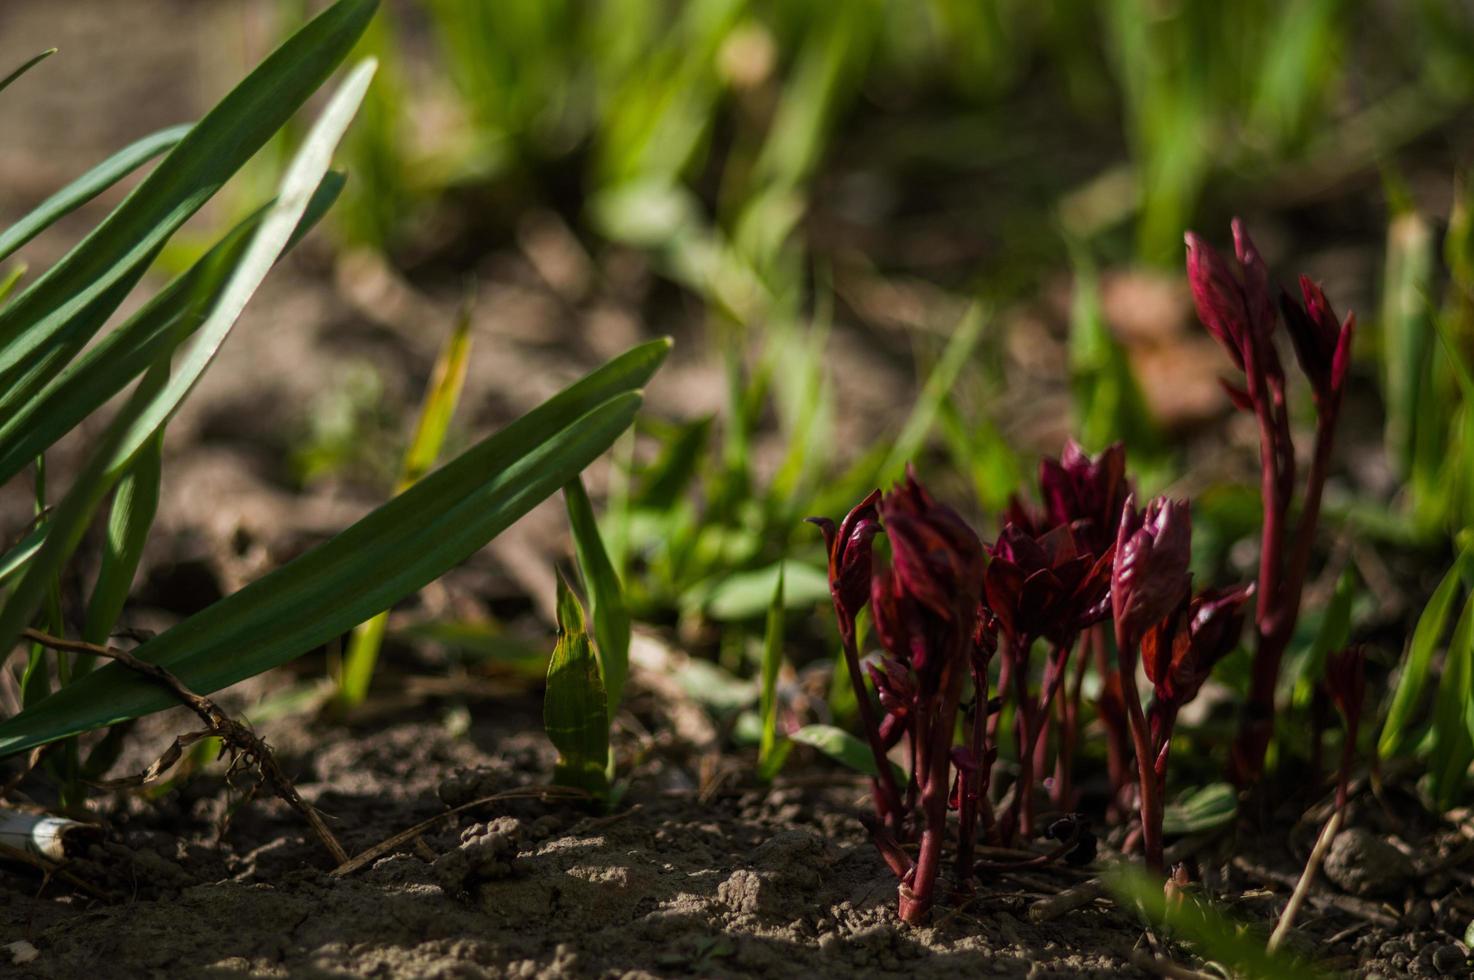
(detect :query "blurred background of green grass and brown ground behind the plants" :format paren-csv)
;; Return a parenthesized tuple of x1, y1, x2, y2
(0, 0, 1474, 722)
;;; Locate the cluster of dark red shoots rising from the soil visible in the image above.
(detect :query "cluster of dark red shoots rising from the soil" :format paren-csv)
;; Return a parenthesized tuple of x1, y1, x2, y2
(814, 221, 1353, 923)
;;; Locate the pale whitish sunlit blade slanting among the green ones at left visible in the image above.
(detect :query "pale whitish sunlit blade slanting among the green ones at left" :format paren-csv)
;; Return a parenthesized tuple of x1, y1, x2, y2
(0, 62, 374, 648)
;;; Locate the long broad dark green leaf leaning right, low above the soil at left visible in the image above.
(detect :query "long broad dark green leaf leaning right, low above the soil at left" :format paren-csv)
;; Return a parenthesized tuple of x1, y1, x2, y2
(0, 340, 671, 755)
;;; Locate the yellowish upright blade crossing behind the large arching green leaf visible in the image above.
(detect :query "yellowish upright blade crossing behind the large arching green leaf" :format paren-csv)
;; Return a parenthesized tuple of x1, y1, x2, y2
(338, 305, 470, 707)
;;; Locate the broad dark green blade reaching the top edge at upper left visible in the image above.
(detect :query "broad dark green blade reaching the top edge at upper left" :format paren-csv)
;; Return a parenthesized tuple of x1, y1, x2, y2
(0, 0, 376, 400)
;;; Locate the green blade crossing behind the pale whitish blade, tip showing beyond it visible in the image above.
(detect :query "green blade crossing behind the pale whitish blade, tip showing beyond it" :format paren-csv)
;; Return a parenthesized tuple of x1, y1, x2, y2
(0, 172, 343, 483)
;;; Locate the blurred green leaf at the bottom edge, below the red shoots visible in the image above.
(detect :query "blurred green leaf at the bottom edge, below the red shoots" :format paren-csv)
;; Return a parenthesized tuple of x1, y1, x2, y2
(1107, 865, 1321, 980)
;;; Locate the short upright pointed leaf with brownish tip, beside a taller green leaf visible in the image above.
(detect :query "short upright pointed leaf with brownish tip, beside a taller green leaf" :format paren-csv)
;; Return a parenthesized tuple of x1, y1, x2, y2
(542, 575, 609, 799)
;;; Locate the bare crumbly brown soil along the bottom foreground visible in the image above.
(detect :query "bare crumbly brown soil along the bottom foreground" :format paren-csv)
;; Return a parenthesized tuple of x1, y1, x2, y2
(0, 660, 1474, 980)
